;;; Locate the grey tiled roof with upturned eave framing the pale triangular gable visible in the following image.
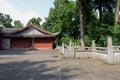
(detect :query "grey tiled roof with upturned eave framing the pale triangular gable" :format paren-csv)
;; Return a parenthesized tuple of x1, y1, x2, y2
(2, 24, 58, 37)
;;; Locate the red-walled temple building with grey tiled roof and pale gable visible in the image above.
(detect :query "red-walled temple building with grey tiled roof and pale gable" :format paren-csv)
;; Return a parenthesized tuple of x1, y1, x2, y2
(0, 24, 58, 49)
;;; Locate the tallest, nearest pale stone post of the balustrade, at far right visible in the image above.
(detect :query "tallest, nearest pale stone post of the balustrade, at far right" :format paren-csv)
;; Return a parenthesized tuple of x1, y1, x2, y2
(107, 37, 114, 64)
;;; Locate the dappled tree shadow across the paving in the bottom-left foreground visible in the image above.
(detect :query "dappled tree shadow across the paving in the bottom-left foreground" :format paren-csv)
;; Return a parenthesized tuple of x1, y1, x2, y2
(0, 60, 75, 80)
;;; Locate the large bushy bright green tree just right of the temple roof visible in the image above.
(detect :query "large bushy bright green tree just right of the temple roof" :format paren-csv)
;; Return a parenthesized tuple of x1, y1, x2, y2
(43, 0, 79, 43)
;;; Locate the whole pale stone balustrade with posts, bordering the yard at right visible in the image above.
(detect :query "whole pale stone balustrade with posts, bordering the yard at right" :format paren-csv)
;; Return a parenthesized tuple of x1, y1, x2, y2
(62, 37, 120, 64)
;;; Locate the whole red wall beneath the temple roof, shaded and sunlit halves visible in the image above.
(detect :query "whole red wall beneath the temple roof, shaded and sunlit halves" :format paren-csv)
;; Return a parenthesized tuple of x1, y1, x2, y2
(11, 38, 53, 49)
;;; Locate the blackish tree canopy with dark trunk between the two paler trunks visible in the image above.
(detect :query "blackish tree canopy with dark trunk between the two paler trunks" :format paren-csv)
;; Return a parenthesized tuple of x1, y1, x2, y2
(93, 0, 115, 26)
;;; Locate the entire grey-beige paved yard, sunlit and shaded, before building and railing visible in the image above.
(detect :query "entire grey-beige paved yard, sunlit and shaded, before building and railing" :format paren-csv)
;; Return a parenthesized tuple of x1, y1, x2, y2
(0, 50, 120, 80)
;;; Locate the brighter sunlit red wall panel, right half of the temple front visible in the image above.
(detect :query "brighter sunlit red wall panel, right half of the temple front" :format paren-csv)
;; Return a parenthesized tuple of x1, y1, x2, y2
(34, 38, 53, 49)
